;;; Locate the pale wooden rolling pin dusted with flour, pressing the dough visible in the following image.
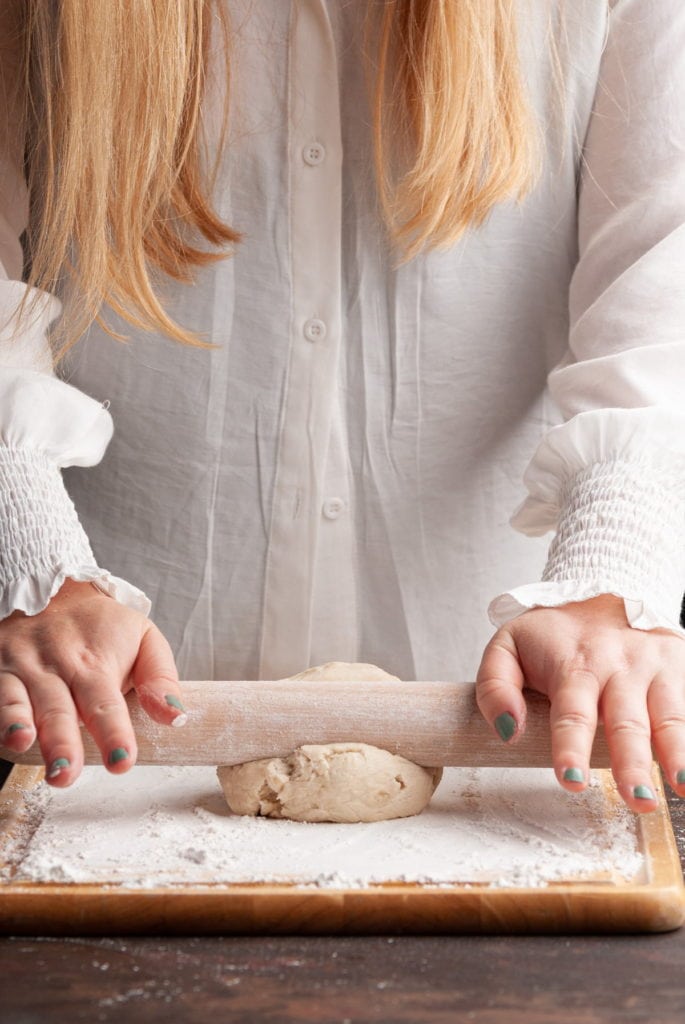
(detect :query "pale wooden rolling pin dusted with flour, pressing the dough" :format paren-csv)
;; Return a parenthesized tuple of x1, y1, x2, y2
(2, 679, 609, 768)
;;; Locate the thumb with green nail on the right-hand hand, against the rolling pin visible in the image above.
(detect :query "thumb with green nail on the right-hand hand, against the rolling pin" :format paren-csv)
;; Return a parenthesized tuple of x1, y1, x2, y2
(476, 628, 525, 742)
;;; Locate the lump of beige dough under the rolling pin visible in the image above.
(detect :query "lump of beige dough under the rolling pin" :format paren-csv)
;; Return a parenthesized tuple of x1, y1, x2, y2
(217, 662, 442, 822)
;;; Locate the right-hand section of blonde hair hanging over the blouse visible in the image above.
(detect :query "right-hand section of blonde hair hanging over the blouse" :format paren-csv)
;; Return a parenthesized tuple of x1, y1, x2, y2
(367, 0, 540, 262)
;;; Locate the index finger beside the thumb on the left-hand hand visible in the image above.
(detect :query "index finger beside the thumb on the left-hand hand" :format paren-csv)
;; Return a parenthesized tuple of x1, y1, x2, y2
(71, 666, 138, 775)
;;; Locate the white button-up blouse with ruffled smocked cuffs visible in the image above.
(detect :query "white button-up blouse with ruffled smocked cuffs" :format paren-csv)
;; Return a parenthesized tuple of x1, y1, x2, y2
(0, 0, 685, 679)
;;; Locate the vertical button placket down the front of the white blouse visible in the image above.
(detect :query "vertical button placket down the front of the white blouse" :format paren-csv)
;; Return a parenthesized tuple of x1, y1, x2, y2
(259, 0, 342, 679)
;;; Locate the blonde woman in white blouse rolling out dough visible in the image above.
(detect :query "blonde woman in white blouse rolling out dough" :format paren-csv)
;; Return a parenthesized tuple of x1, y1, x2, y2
(0, 0, 685, 811)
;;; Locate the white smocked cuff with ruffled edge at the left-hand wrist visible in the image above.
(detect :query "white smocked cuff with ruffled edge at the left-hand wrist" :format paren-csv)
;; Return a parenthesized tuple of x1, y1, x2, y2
(0, 446, 151, 618)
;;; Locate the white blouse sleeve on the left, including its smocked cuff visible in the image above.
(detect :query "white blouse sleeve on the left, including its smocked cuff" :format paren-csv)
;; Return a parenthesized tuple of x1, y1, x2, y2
(0, 18, 151, 618)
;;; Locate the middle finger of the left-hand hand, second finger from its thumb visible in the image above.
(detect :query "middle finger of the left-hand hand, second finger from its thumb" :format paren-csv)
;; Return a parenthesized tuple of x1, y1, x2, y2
(23, 669, 83, 787)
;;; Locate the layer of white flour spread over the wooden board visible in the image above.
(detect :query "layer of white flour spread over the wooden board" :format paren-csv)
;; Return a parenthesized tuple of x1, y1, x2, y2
(2, 767, 644, 889)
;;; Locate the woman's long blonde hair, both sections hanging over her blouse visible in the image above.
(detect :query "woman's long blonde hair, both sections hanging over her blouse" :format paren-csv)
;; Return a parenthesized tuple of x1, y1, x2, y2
(10, 0, 539, 358)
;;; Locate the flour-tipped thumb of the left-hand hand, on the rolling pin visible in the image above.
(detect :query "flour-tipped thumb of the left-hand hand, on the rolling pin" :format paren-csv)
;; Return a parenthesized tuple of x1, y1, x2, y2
(131, 623, 187, 727)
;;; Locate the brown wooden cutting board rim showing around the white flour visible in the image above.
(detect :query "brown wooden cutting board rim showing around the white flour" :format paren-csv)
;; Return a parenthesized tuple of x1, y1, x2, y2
(0, 765, 685, 935)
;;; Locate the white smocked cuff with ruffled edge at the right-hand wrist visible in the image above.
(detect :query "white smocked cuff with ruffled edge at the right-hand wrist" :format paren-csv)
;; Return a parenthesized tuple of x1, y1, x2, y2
(488, 459, 685, 637)
